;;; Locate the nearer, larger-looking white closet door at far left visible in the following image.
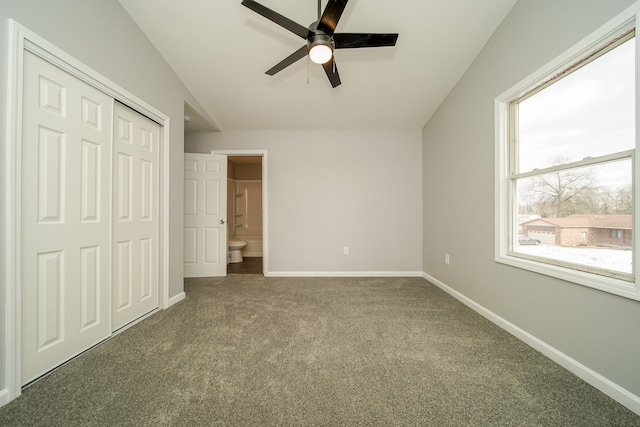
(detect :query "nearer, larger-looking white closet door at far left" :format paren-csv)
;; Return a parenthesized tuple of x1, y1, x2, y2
(21, 51, 113, 384)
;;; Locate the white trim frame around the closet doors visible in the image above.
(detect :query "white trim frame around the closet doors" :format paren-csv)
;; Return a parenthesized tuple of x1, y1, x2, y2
(0, 20, 170, 406)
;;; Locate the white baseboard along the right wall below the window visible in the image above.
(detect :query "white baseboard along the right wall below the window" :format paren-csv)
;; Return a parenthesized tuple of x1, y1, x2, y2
(422, 273, 640, 415)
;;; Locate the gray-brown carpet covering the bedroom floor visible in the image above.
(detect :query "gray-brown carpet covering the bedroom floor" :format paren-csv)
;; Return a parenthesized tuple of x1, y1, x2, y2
(0, 275, 640, 426)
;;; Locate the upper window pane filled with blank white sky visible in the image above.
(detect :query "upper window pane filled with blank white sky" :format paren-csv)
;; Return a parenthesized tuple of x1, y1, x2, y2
(517, 37, 635, 172)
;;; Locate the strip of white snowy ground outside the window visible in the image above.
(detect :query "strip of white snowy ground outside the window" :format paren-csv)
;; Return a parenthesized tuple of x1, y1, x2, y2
(517, 244, 633, 273)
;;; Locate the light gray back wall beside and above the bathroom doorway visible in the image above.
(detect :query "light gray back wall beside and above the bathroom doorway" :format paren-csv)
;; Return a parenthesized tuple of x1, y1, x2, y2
(185, 129, 422, 273)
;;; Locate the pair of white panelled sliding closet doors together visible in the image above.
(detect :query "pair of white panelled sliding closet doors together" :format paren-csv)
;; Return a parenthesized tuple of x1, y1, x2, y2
(20, 51, 159, 384)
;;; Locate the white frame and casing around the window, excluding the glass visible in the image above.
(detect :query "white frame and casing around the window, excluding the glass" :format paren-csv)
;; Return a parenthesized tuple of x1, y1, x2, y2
(495, 2, 640, 300)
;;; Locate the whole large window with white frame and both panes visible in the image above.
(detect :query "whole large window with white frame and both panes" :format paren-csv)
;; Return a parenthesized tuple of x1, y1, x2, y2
(496, 7, 640, 299)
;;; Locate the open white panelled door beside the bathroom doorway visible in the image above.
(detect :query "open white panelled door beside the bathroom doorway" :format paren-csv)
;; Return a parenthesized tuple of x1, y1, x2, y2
(184, 153, 227, 277)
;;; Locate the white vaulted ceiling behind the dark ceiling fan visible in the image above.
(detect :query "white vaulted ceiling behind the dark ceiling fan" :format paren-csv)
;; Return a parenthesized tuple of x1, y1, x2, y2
(120, 0, 516, 130)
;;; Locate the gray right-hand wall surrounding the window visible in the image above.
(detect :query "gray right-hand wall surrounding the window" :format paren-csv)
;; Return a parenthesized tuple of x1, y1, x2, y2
(423, 0, 640, 396)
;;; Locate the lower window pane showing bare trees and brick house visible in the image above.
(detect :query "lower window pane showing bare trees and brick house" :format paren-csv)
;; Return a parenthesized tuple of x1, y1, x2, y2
(512, 158, 633, 274)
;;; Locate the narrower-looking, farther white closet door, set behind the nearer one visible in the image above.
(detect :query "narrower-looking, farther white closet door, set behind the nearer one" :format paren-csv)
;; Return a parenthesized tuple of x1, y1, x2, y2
(112, 102, 160, 330)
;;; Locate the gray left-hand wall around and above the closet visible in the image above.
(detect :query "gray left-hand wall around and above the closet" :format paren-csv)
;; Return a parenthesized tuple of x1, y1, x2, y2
(0, 0, 208, 391)
